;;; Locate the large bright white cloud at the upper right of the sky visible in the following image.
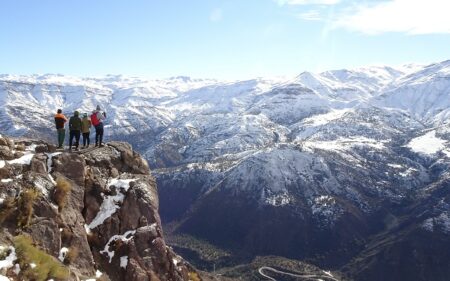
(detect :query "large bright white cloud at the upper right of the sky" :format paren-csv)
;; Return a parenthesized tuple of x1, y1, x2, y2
(333, 0, 450, 35)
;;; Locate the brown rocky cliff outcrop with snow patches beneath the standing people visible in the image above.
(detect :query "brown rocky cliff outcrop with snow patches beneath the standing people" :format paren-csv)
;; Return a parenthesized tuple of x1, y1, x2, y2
(0, 136, 198, 281)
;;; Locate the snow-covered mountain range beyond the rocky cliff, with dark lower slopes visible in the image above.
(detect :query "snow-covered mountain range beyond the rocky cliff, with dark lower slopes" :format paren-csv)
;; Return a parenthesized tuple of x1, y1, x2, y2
(0, 61, 450, 280)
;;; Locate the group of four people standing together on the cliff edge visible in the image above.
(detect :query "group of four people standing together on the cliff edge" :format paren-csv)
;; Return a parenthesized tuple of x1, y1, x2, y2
(55, 105, 106, 151)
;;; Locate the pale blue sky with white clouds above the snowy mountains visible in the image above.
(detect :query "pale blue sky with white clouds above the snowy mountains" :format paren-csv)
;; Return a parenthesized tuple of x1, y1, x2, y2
(0, 0, 450, 79)
